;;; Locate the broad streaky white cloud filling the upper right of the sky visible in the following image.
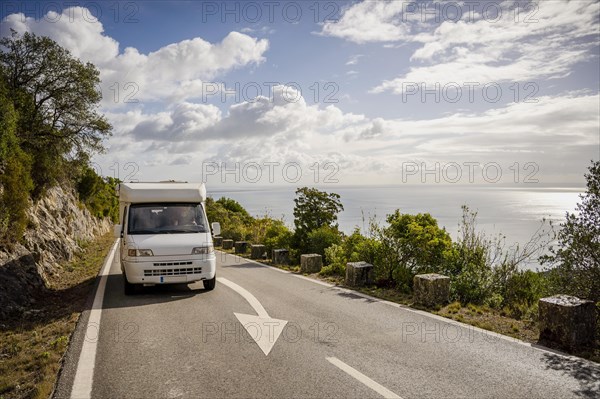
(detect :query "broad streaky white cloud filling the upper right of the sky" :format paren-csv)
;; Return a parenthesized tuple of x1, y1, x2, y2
(321, 0, 600, 94)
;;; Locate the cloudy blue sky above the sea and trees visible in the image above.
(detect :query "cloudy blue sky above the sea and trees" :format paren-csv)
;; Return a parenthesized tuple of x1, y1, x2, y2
(0, 0, 600, 187)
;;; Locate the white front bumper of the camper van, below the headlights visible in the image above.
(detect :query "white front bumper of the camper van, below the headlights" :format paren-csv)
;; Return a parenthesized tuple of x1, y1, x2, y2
(122, 254, 216, 284)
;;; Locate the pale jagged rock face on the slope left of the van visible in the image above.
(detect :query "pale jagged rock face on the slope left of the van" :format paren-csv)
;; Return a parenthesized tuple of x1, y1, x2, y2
(0, 187, 111, 320)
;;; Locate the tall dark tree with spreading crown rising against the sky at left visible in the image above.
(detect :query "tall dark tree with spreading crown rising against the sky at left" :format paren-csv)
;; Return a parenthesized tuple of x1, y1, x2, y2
(0, 31, 111, 194)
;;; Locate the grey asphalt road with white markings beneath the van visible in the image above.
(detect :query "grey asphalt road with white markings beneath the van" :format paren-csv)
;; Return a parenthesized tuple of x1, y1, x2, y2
(55, 244, 600, 399)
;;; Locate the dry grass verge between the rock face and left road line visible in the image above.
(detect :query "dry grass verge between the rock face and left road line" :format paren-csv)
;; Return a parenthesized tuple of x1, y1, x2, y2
(0, 233, 114, 399)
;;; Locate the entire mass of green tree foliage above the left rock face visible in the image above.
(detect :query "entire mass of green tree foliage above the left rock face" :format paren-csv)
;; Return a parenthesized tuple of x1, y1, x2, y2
(0, 31, 116, 245)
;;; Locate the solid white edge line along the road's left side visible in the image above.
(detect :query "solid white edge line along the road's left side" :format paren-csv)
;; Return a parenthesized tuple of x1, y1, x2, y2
(71, 240, 119, 399)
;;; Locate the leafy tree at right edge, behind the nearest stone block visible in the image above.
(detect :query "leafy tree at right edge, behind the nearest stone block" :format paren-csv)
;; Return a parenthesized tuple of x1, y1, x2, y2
(541, 161, 600, 302)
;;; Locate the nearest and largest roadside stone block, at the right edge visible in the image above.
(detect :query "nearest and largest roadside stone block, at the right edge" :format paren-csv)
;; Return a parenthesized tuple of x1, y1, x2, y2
(538, 295, 597, 349)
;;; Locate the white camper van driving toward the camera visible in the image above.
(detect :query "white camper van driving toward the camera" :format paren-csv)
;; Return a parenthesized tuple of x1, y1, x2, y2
(115, 181, 221, 295)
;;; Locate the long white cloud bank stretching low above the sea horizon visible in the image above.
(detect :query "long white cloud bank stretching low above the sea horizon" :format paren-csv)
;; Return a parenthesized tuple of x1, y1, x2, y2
(98, 86, 600, 182)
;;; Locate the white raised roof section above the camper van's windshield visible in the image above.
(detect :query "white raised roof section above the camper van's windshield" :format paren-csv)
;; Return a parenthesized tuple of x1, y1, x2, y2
(119, 182, 206, 203)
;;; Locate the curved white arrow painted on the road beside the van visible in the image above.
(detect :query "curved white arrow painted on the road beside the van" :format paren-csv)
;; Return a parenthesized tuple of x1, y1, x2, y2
(217, 277, 287, 356)
